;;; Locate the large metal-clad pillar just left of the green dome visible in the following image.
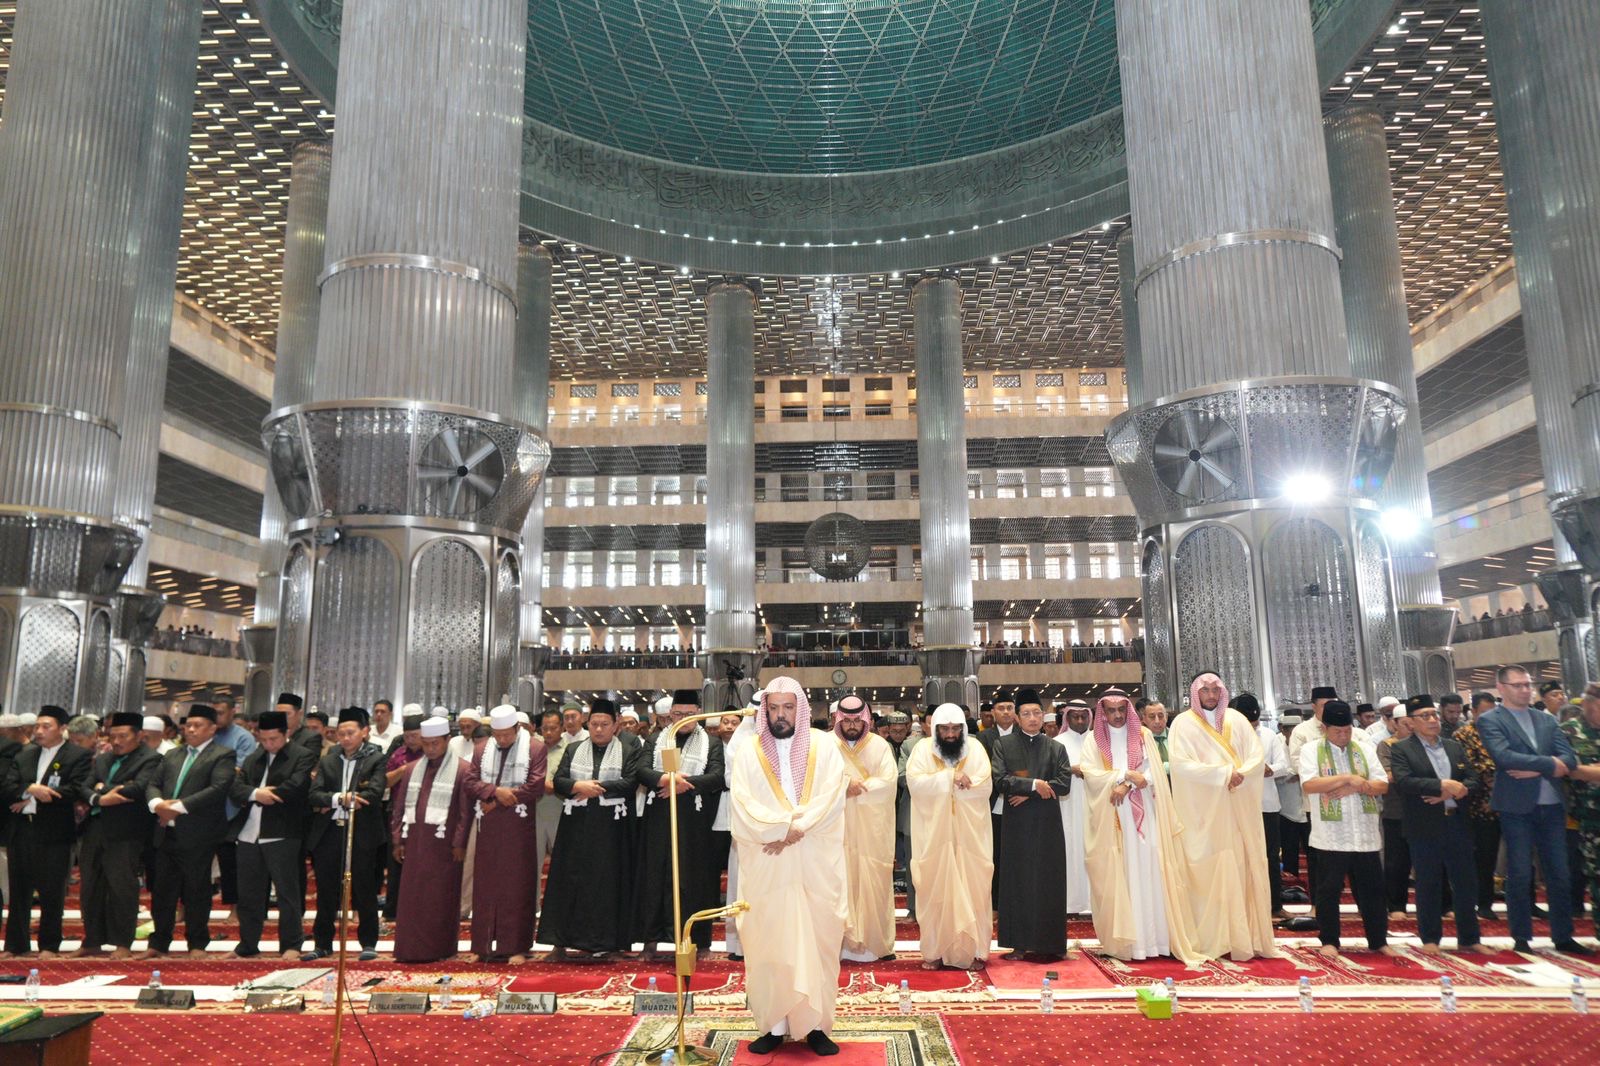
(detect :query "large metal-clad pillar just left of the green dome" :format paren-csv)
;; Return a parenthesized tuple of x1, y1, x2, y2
(262, 0, 549, 707)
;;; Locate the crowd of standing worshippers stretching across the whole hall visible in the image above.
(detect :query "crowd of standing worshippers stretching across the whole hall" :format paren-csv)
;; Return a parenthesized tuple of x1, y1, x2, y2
(0, 667, 1600, 973)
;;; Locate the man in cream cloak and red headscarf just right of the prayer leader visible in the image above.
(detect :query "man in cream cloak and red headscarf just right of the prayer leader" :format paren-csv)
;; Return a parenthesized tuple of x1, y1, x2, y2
(834, 696, 899, 962)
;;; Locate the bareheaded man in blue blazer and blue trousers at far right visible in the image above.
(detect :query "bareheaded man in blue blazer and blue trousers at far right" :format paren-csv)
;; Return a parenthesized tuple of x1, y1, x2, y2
(1477, 666, 1594, 956)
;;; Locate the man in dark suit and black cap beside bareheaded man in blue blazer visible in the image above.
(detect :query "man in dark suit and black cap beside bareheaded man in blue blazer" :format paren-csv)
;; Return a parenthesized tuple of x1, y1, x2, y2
(1387, 696, 1483, 954)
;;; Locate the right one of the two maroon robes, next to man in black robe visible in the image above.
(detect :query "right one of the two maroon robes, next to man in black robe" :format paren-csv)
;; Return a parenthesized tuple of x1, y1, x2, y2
(461, 736, 547, 959)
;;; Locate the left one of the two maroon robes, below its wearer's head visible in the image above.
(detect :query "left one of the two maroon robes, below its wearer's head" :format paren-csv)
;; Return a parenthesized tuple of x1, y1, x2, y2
(389, 755, 472, 962)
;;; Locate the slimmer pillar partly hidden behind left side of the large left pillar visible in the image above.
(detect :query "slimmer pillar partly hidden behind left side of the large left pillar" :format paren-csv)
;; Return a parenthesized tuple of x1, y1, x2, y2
(240, 141, 333, 714)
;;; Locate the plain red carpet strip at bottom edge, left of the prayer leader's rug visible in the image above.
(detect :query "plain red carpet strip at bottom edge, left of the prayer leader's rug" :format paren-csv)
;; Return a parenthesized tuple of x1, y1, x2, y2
(90, 1008, 634, 1066)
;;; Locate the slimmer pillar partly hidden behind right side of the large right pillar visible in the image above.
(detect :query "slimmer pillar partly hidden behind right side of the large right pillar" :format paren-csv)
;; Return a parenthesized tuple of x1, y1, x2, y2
(1323, 106, 1456, 696)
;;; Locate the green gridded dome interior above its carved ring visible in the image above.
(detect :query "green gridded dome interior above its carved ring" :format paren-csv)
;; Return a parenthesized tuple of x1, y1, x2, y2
(526, 0, 1120, 173)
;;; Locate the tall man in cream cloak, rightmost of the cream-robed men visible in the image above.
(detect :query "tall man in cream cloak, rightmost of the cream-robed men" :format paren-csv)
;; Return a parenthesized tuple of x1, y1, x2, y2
(1166, 674, 1278, 962)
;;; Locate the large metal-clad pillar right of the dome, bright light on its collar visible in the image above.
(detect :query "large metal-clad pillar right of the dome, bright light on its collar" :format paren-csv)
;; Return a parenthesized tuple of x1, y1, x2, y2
(1107, 0, 1405, 714)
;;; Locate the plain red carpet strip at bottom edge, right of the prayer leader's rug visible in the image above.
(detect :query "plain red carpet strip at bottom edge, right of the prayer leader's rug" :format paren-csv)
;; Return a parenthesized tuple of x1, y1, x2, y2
(946, 1008, 1600, 1066)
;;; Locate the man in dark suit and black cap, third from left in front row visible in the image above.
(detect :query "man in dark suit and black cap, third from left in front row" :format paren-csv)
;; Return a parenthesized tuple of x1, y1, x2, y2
(147, 703, 234, 959)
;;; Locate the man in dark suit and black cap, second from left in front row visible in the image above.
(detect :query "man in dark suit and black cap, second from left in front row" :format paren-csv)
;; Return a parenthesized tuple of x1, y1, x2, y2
(74, 711, 162, 959)
